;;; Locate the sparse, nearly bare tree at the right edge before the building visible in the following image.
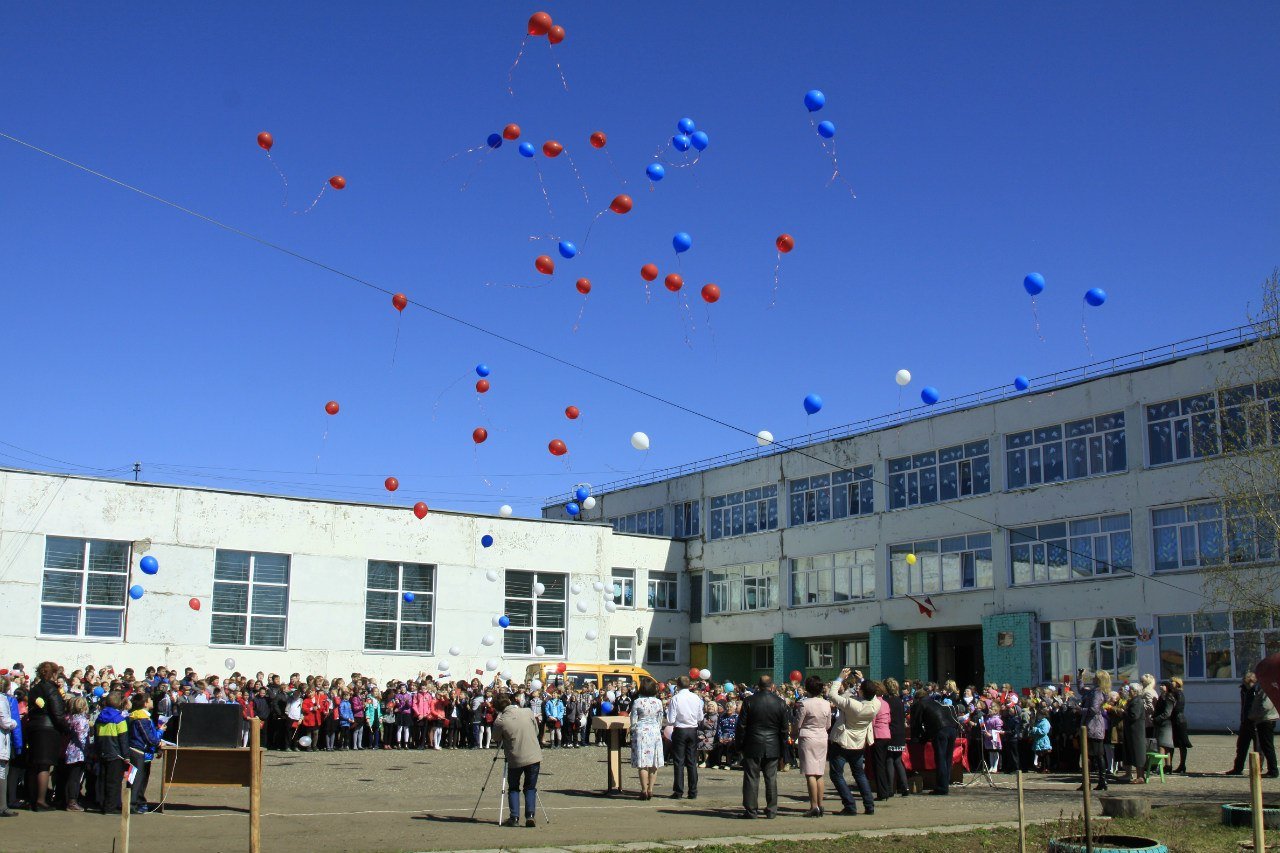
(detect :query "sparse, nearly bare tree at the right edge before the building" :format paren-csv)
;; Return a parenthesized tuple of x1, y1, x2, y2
(1204, 268, 1280, 620)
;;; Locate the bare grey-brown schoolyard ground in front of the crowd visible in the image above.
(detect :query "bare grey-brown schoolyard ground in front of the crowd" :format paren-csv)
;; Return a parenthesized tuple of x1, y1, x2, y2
(0, 735, 1280, 853)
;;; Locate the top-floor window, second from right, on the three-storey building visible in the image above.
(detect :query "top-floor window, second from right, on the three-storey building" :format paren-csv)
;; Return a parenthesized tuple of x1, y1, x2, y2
(1005, 411, 1129, 489)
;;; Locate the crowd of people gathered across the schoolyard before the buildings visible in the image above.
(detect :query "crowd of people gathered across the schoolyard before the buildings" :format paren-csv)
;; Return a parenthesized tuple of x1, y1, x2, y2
(0, 653, 1277, 820)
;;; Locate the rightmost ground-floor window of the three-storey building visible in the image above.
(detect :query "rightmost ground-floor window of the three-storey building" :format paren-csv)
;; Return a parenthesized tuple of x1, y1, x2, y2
(1156, 611, 1280, 681)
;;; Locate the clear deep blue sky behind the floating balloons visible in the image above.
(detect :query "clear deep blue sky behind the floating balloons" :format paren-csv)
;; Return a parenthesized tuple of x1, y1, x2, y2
(0, 3, 1280, 512)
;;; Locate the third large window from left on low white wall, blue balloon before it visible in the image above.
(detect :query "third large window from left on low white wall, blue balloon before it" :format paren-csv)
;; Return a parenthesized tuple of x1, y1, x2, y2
(365, 560, 435, 654)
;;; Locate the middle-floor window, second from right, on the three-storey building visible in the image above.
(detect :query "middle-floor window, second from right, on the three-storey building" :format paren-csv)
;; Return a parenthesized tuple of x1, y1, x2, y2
(1009, 512, 1133, 584)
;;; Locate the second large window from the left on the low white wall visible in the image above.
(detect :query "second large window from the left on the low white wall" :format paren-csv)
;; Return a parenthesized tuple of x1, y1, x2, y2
(209, 549, 289, 648)
